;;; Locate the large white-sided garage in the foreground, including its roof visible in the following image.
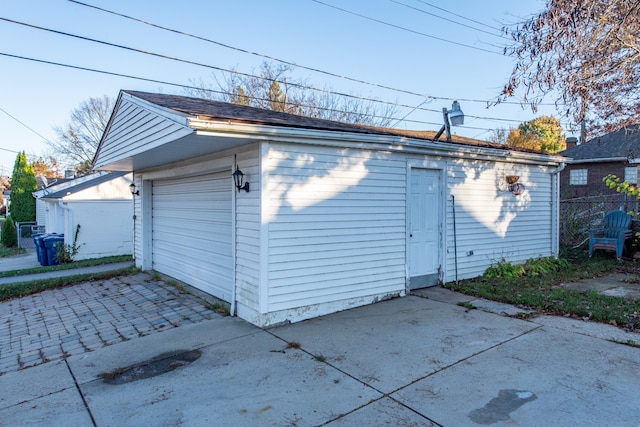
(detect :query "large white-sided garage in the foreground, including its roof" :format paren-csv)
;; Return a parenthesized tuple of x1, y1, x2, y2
(94, 91, 563, 327)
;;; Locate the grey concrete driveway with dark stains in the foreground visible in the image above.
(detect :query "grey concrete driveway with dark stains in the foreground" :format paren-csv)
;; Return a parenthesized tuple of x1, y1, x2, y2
(0, 276, 640, 427)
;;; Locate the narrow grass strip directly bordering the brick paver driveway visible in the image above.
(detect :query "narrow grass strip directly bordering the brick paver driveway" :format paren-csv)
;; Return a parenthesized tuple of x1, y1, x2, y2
(0, 267, 138, 301)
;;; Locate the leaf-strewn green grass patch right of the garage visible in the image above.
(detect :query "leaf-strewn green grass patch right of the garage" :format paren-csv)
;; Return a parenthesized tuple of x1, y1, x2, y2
(446, 252, 640, 330)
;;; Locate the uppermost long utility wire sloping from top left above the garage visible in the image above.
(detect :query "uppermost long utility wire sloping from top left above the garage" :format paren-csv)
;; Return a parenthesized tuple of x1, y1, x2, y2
(68, 0, 546, 105)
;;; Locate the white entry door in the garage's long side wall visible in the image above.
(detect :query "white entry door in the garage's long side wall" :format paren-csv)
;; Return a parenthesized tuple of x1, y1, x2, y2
(408, 168, 442, 289)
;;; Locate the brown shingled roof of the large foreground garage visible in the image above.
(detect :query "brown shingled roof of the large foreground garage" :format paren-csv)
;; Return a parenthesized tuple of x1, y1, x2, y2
(122, 90, 537, 153)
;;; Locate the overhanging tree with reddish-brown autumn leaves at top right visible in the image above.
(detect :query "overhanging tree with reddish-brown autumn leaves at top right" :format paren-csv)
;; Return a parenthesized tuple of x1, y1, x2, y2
(498, 0, 640, 135)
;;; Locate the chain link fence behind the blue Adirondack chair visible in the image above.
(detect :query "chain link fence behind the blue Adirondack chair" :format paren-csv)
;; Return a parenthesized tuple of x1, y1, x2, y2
(560, 194, 640, 247)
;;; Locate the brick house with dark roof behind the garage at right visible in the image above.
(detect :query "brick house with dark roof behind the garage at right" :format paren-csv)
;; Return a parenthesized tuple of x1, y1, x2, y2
(559, 125, 640, 199)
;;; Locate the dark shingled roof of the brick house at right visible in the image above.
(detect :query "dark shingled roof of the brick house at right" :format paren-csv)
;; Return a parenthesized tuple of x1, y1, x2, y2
(560, 125, 640, 163)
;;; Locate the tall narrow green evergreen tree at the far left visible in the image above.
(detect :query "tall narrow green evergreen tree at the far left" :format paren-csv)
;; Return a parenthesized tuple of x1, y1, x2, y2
(9, 151, 38, 222)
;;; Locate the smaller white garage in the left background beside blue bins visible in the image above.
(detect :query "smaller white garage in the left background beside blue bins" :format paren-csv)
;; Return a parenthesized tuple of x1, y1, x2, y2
(33, 172, 133, 260)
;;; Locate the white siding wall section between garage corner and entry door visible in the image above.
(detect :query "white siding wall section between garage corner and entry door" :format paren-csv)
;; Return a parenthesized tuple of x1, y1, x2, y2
(263, 144, 406, 312)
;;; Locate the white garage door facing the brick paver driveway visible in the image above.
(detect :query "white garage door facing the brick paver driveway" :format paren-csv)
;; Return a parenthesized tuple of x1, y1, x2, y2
(152, 172, 233, 301)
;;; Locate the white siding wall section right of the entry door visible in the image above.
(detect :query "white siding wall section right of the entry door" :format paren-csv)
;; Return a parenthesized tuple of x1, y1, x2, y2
(445, 162, 555, 281)
